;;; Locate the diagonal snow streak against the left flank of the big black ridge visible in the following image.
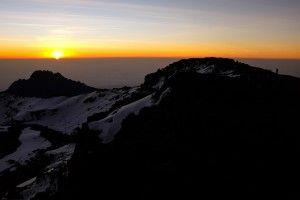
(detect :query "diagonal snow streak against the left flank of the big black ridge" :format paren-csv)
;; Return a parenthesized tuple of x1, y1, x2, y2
(89, 95, 154, 143)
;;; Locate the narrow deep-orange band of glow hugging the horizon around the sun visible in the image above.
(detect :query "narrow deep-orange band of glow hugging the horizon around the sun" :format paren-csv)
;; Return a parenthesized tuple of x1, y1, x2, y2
(0, 45, 300, 59)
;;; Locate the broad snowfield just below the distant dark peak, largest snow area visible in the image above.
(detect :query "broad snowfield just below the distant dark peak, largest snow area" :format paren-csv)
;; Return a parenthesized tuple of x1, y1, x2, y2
(0, 87, 137, 134)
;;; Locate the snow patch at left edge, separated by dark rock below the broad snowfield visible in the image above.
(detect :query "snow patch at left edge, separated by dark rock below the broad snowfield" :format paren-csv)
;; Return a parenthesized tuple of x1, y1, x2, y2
(0, 128, 51, 172)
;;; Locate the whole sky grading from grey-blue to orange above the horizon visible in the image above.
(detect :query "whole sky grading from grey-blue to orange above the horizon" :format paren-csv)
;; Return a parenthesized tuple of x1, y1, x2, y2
(0, 0, 300, 59)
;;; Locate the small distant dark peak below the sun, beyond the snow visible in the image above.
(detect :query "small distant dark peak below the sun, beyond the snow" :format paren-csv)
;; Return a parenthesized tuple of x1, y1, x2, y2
(6, 70, 96, 98)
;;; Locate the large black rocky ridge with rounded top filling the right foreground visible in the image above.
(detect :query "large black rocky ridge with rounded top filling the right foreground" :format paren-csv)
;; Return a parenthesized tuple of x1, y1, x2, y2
(55, 58, 300, 199)
